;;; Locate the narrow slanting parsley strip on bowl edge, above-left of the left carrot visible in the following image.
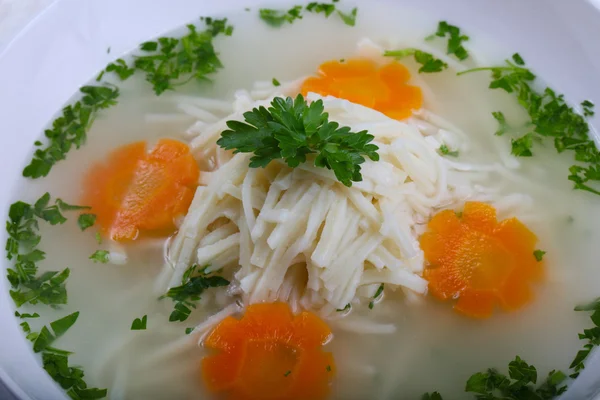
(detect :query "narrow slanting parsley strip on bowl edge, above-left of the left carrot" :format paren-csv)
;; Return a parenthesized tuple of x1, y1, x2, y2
(23, 86, 119, 179)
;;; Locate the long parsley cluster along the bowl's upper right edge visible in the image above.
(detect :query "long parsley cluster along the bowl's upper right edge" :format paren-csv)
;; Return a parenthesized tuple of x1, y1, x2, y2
(458, 54, 600, 195)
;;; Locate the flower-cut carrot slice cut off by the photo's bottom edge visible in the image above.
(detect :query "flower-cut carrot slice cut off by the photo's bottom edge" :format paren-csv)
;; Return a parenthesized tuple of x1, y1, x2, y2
(202, 303, 335, 400)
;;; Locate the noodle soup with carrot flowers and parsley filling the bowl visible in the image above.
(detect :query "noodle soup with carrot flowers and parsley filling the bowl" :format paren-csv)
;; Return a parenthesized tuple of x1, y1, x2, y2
(7, 3, 599, 399)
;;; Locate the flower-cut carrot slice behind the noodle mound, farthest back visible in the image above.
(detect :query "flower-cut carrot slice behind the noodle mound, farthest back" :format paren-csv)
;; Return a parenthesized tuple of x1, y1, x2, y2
(301, 59, 423, 119)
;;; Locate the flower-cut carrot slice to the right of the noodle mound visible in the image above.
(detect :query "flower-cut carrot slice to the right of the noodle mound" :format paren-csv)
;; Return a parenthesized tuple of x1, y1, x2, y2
(420, 202, 544, 318)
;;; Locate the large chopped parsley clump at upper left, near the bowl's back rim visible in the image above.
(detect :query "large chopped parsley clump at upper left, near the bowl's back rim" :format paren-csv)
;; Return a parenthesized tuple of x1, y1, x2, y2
(106, 18, 233, 95)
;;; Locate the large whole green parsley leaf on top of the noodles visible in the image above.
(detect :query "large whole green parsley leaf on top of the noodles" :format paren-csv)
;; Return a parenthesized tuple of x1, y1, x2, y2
(217, 94, 379, 186)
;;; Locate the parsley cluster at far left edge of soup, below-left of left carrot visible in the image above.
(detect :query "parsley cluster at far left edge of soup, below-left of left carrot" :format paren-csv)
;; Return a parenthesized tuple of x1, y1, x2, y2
(6, 193, 87, 307)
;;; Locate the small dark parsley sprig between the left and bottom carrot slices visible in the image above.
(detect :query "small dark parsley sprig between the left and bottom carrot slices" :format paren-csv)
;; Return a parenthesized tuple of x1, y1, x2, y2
(160, 264, 229, 322)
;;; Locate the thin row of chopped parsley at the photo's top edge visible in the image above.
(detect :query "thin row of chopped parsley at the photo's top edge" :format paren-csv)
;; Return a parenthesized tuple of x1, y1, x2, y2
(258, 1, 358, 28)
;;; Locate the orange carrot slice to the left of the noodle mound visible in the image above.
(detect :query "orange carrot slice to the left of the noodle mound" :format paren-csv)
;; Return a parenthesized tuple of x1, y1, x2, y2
(82, 139, 199, 241)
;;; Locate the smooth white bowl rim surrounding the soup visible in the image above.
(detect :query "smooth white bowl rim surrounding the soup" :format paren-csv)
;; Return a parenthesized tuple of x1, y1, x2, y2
(0, 0, 600, 400)
